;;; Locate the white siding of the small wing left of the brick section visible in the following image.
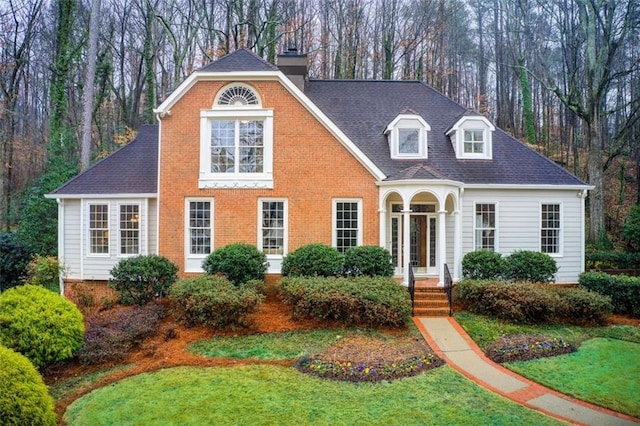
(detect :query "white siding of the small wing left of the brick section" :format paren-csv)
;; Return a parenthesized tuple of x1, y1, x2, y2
(60, 198, 157, 280)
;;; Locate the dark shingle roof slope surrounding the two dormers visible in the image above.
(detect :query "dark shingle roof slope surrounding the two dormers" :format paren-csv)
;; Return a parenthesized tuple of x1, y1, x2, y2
(305, 80, 585, 185)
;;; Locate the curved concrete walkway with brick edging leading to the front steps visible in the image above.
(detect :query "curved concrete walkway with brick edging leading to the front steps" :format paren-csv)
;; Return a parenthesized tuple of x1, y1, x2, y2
(414, 317, 640, 426)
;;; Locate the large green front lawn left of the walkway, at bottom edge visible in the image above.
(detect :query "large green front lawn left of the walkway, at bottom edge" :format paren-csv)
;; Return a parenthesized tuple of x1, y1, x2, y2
(65, 365, 561, 425)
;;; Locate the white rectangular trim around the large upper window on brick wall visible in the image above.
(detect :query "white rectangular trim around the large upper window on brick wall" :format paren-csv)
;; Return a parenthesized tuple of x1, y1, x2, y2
(198, 105, 273, 189)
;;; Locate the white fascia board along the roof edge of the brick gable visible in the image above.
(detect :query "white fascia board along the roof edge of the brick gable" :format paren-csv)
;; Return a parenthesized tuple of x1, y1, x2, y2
(153, 71, 386, 180)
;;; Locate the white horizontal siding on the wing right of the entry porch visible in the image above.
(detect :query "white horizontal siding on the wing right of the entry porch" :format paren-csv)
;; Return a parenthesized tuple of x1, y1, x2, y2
(462, 189, 584, 283)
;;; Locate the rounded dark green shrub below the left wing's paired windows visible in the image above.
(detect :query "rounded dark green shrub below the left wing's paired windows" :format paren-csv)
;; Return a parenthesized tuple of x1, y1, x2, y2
(109, 254, 178, 306)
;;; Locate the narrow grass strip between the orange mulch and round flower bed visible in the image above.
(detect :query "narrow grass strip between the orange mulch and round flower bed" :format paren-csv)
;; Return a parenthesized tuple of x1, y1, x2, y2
(187, 329, 383, 360)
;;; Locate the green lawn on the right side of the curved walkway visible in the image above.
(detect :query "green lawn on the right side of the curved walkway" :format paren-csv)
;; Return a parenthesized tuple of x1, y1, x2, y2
(456, 312, 640, 417)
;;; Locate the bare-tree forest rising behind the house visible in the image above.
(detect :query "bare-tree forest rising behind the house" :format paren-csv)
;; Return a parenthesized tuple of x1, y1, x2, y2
(0, 0, 640, 254)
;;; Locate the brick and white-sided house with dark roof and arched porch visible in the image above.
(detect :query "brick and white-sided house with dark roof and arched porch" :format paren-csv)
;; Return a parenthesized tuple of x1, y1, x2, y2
(49, 50, 589, 296)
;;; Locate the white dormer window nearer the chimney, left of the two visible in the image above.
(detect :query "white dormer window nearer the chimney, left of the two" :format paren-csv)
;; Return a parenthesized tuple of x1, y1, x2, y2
(385, 114, 431, 159)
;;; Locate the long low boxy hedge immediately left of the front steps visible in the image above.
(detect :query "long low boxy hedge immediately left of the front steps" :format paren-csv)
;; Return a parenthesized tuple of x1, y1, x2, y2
(281, 277, 411, 327)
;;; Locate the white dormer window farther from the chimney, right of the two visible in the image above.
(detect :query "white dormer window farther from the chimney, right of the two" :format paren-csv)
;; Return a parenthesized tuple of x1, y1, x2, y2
(447, 115, 495, 160)
